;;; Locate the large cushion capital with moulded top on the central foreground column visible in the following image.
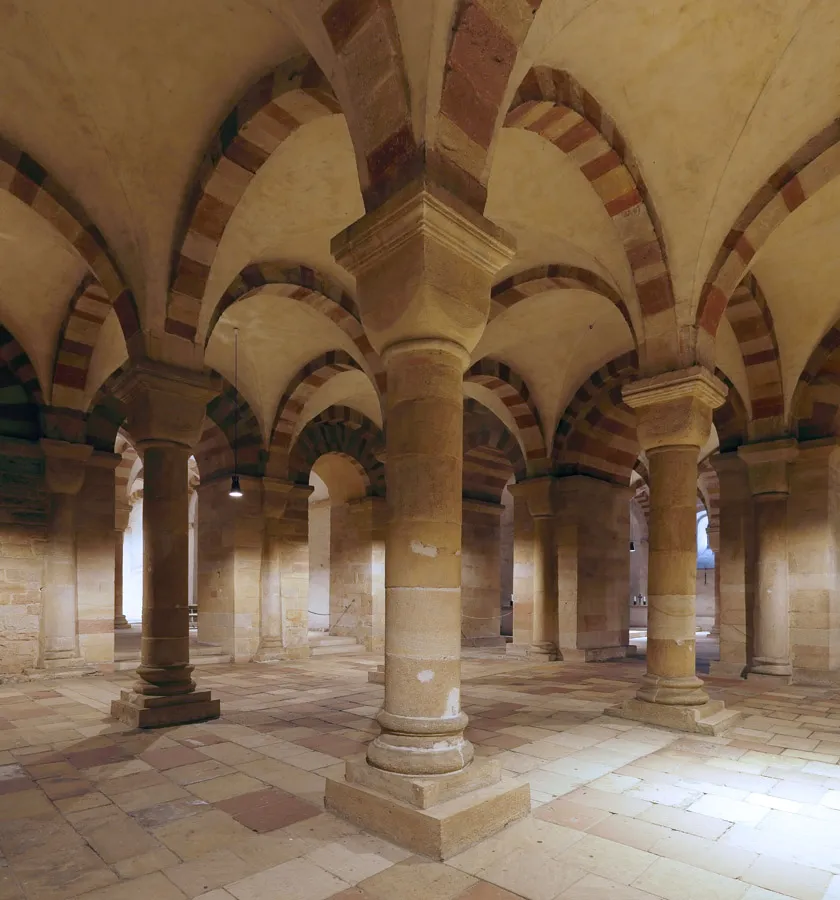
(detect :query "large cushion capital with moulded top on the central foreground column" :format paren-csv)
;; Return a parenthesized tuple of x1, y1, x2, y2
(331, 181, 515, 354)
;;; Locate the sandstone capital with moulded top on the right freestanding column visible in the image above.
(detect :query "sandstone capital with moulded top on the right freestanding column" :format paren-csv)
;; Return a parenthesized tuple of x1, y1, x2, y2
(622, 366, 726, 452)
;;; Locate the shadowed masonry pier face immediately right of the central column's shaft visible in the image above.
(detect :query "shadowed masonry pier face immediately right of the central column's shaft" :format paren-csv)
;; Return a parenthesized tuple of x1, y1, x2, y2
(461, 499, 503, 646)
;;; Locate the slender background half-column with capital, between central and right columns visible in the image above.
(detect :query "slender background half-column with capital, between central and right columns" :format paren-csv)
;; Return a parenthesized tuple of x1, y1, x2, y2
(510, 475, 559, 662)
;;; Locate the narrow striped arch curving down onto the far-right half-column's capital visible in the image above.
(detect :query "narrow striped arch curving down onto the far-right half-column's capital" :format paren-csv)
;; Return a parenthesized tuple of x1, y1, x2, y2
(726, 274, 785, 436)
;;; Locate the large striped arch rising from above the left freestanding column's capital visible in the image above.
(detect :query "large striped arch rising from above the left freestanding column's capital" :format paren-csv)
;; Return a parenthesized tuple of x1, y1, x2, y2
(164, 55, 340, 341)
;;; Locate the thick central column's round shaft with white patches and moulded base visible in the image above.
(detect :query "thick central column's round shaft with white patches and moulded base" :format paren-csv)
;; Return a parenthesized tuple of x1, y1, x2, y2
(368, 340, 473, 775)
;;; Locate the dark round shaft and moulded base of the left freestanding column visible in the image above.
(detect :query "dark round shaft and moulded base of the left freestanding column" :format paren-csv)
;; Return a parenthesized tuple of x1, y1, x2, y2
(134, 444, 195, 696)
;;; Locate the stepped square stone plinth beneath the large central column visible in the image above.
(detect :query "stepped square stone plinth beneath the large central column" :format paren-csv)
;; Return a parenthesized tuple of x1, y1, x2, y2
(324, 756, 531, 859)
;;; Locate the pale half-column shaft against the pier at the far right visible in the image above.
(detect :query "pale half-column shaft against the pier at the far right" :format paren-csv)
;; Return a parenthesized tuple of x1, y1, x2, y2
(752, 494, 792, 675)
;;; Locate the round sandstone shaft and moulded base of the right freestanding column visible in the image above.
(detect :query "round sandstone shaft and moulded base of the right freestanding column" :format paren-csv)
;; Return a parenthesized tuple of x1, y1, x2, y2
(636, 445, 708, 706)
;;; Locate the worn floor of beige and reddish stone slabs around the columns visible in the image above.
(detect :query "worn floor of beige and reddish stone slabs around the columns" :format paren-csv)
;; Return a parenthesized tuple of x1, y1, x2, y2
(0, 651, 840, 900)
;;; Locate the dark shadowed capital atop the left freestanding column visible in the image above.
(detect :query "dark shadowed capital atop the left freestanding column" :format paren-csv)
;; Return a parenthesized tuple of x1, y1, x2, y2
(114, 359, 219, 449)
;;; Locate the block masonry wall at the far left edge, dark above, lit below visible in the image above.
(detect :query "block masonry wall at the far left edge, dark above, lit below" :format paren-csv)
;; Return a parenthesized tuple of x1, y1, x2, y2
(0, 440, 48, 674)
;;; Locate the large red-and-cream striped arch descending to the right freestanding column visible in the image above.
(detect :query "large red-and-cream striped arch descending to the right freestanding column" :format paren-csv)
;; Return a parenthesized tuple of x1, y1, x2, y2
(505, 66, 675, 319)
